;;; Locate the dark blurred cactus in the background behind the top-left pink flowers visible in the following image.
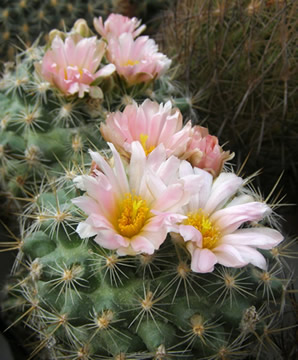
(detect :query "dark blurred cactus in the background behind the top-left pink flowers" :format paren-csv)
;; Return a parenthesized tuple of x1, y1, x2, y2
(0, 0, 167, 61)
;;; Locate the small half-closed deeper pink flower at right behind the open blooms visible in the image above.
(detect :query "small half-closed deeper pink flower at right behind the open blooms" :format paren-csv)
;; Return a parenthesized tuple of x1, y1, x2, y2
(183, 126, 234, 177)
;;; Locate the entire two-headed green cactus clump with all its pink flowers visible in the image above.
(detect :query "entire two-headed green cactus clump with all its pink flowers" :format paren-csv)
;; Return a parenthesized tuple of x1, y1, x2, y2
(0, 7, 295, 360)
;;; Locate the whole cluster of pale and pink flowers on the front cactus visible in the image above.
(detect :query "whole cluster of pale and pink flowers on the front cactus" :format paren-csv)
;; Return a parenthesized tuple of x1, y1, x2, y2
(73, 95, 283, 273)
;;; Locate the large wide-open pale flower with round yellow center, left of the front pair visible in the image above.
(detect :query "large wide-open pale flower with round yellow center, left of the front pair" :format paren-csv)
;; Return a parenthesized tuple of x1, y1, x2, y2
(73, 142, 196, 255)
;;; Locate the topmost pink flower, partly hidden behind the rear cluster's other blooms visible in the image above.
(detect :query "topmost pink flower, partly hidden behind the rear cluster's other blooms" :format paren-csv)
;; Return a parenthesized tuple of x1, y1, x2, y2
(93, 14, 146, 41)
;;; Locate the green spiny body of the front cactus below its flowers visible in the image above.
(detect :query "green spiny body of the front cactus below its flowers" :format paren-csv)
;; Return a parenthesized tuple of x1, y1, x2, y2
(3, 183, 295, 360)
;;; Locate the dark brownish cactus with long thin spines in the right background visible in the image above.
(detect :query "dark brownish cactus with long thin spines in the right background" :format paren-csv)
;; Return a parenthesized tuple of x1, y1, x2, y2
(158, 0, 298, 203)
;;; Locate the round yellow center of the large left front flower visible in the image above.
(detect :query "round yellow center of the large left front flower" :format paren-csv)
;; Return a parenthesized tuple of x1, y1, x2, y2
(118, 194, 149, 238)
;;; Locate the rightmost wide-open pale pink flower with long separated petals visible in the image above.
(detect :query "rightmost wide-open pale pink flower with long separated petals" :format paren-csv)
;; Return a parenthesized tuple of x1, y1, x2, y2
(172, 164, 283, 273)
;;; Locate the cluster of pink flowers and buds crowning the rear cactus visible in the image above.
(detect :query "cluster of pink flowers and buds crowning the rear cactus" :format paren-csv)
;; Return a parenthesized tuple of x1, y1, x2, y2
(35, 14, 171, 98)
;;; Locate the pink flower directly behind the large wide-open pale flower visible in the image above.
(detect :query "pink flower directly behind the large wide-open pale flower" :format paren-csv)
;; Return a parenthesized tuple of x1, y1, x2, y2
(100, 99, 191, 158)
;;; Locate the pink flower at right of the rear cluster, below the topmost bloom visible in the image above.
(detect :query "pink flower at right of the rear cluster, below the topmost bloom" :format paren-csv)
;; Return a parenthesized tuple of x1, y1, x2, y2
(107, 33, 171, 85)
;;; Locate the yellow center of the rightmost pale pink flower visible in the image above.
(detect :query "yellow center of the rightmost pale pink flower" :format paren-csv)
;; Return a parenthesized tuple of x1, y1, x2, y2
(184, 209, 220, 249)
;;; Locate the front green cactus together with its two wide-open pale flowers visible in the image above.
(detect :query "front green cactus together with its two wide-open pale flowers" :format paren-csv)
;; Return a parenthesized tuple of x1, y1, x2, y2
(2, 134, 295, 360)
